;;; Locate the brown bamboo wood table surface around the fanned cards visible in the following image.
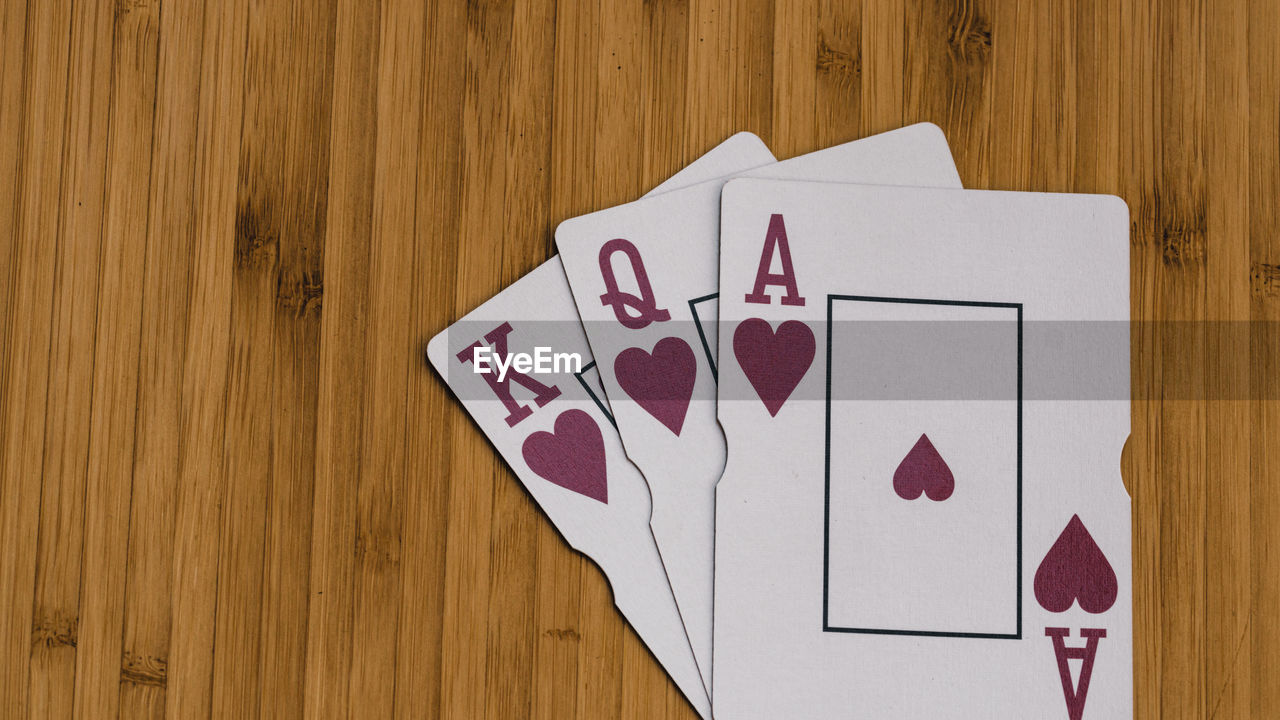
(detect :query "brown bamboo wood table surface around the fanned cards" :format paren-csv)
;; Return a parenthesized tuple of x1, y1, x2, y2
(0, 0, 1280, 720)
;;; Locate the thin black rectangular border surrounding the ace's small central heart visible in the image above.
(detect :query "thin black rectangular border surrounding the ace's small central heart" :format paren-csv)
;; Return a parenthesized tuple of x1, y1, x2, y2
(822, 295, 1023, 641)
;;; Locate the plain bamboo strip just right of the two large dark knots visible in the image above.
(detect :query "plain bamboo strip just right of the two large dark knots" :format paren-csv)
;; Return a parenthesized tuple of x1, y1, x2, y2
(302, 0, 380, 717)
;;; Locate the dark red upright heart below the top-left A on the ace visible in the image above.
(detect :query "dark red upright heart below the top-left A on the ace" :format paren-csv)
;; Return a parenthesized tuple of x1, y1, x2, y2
(733, 318, 817, 416)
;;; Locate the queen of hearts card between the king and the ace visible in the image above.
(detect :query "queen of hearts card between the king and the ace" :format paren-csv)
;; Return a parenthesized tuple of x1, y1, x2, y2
(556, 123, 960, 684)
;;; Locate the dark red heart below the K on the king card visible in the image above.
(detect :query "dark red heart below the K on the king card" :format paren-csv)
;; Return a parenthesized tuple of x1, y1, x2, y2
(522, 410, 609, 505)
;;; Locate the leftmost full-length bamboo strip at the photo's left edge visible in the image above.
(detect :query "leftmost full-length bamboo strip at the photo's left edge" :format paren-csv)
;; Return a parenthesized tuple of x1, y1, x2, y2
(0, 3, 72, 707)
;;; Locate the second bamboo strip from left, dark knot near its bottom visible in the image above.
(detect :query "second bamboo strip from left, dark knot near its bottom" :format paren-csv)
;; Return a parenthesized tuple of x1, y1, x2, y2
(29, 0, 113, 717)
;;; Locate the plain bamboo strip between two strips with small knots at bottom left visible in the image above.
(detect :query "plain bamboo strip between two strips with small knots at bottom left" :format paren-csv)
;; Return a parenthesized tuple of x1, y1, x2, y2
(73, 0, 159, 717)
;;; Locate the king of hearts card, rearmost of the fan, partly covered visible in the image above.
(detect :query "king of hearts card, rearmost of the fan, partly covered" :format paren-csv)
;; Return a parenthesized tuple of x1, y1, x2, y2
(428, 133, 773, 717)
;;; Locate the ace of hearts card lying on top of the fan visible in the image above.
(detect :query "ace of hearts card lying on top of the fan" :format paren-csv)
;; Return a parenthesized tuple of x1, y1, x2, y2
(713, 179, 1133, 720)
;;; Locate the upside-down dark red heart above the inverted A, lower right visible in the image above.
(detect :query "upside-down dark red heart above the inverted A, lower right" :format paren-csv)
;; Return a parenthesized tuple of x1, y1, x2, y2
(1036, 515, 1117, 615)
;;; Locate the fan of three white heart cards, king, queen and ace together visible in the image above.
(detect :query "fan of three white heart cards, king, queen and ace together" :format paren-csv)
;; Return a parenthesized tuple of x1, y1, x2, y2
(428, 123, 1133, 720)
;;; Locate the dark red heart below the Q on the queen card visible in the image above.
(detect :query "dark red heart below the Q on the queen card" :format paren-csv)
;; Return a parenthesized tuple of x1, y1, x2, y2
(613, 337, 698, 436)
